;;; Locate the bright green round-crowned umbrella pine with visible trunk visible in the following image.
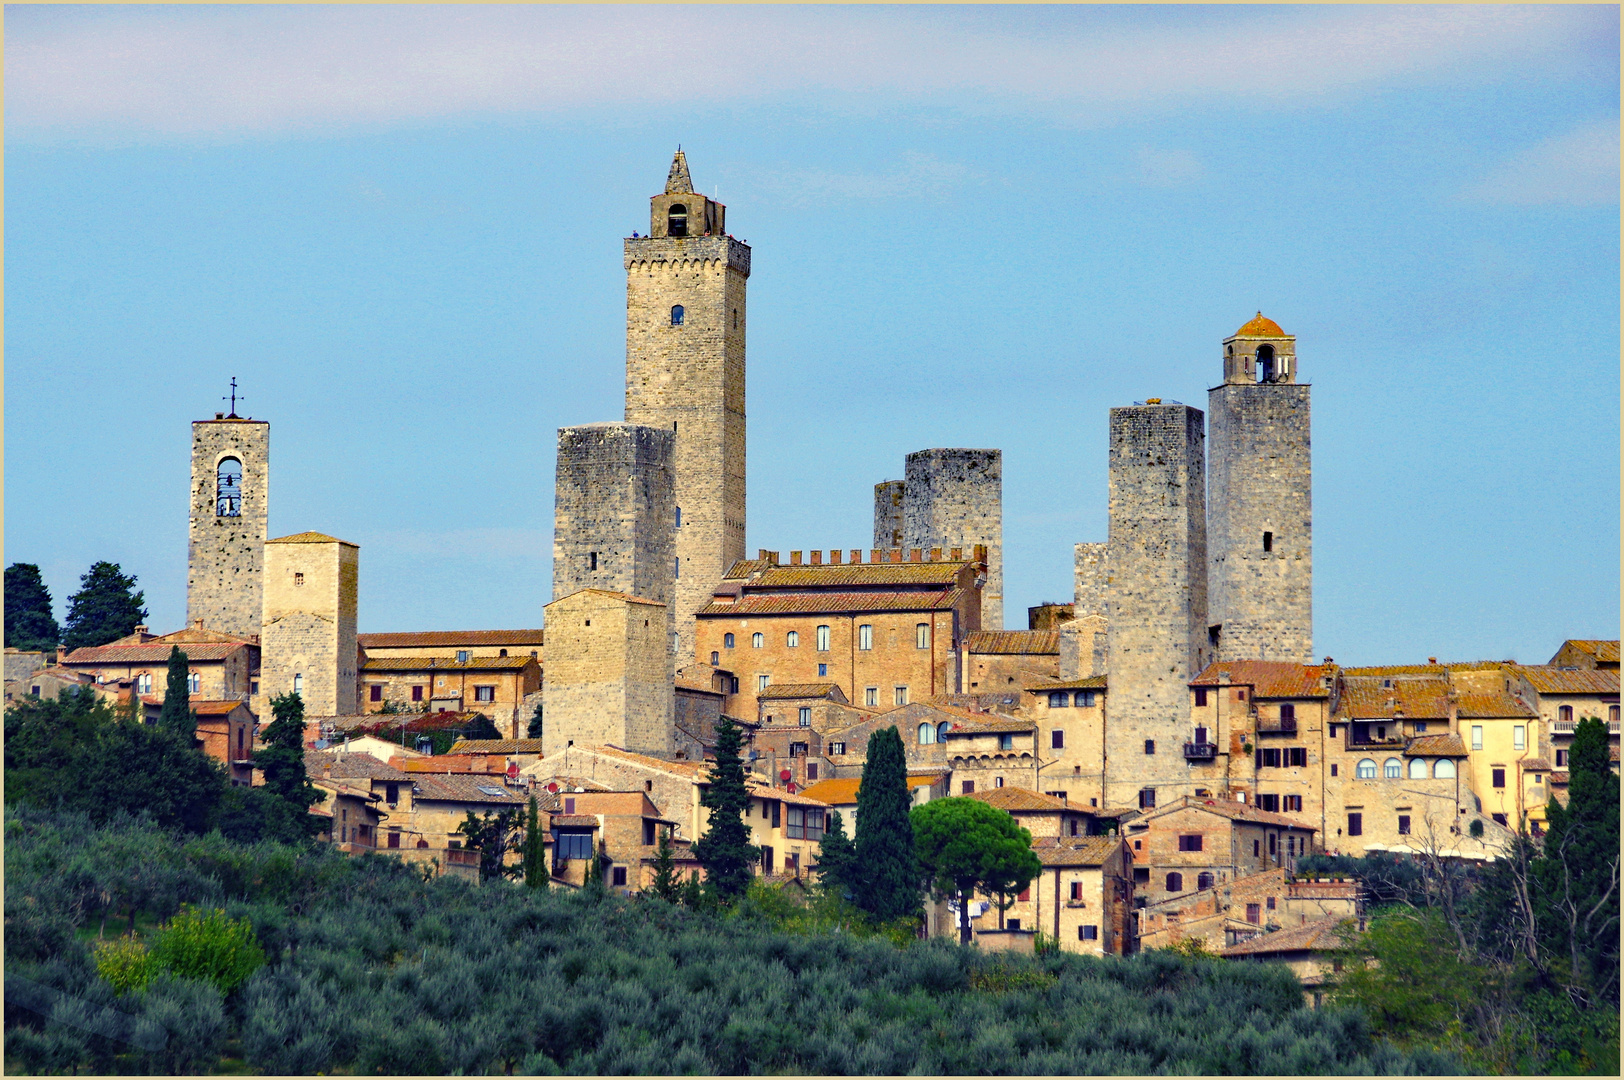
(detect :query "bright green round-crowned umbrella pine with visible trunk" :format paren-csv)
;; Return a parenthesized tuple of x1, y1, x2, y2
(915, 797, 1043, 945)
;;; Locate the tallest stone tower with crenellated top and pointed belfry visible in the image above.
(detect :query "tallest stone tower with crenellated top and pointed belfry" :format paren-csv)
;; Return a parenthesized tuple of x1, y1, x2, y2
(625, 149, 750, 667)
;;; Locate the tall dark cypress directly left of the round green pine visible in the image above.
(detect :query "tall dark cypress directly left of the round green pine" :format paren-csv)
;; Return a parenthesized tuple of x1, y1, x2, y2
(851, 728, 922, 921)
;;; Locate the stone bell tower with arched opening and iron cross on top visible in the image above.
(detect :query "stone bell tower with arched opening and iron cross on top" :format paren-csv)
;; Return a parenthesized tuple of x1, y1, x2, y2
(187, 413, 271, 638)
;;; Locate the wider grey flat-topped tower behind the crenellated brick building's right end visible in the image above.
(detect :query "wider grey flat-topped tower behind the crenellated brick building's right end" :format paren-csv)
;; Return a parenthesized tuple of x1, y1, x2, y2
(902, 450, 1004, 630)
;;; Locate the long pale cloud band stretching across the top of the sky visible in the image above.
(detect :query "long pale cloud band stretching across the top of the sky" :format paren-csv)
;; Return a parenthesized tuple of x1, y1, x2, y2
(5, 5, 1618, 138)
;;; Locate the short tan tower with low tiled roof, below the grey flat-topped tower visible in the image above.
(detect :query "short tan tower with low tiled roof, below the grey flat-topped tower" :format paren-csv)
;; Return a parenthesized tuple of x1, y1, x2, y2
(542, 590, 676, 757)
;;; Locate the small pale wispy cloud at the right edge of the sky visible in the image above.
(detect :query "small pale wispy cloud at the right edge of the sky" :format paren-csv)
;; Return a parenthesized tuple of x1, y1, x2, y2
(1465, 119, 1619, 206)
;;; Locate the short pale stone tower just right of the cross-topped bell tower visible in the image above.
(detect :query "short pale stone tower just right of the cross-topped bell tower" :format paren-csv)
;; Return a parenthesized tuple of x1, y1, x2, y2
(260, 533, 361, 719)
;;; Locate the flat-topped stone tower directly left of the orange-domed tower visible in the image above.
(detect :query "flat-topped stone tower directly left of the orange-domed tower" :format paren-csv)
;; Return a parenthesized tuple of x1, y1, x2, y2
(1104, 398, 1212, 807)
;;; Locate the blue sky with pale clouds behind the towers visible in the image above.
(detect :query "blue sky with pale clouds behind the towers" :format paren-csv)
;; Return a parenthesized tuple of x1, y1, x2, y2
(5, 6, 1619, 663)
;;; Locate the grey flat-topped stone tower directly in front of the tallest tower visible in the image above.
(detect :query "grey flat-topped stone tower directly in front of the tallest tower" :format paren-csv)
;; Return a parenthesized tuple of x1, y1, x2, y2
(552, 424, 676, 648)
